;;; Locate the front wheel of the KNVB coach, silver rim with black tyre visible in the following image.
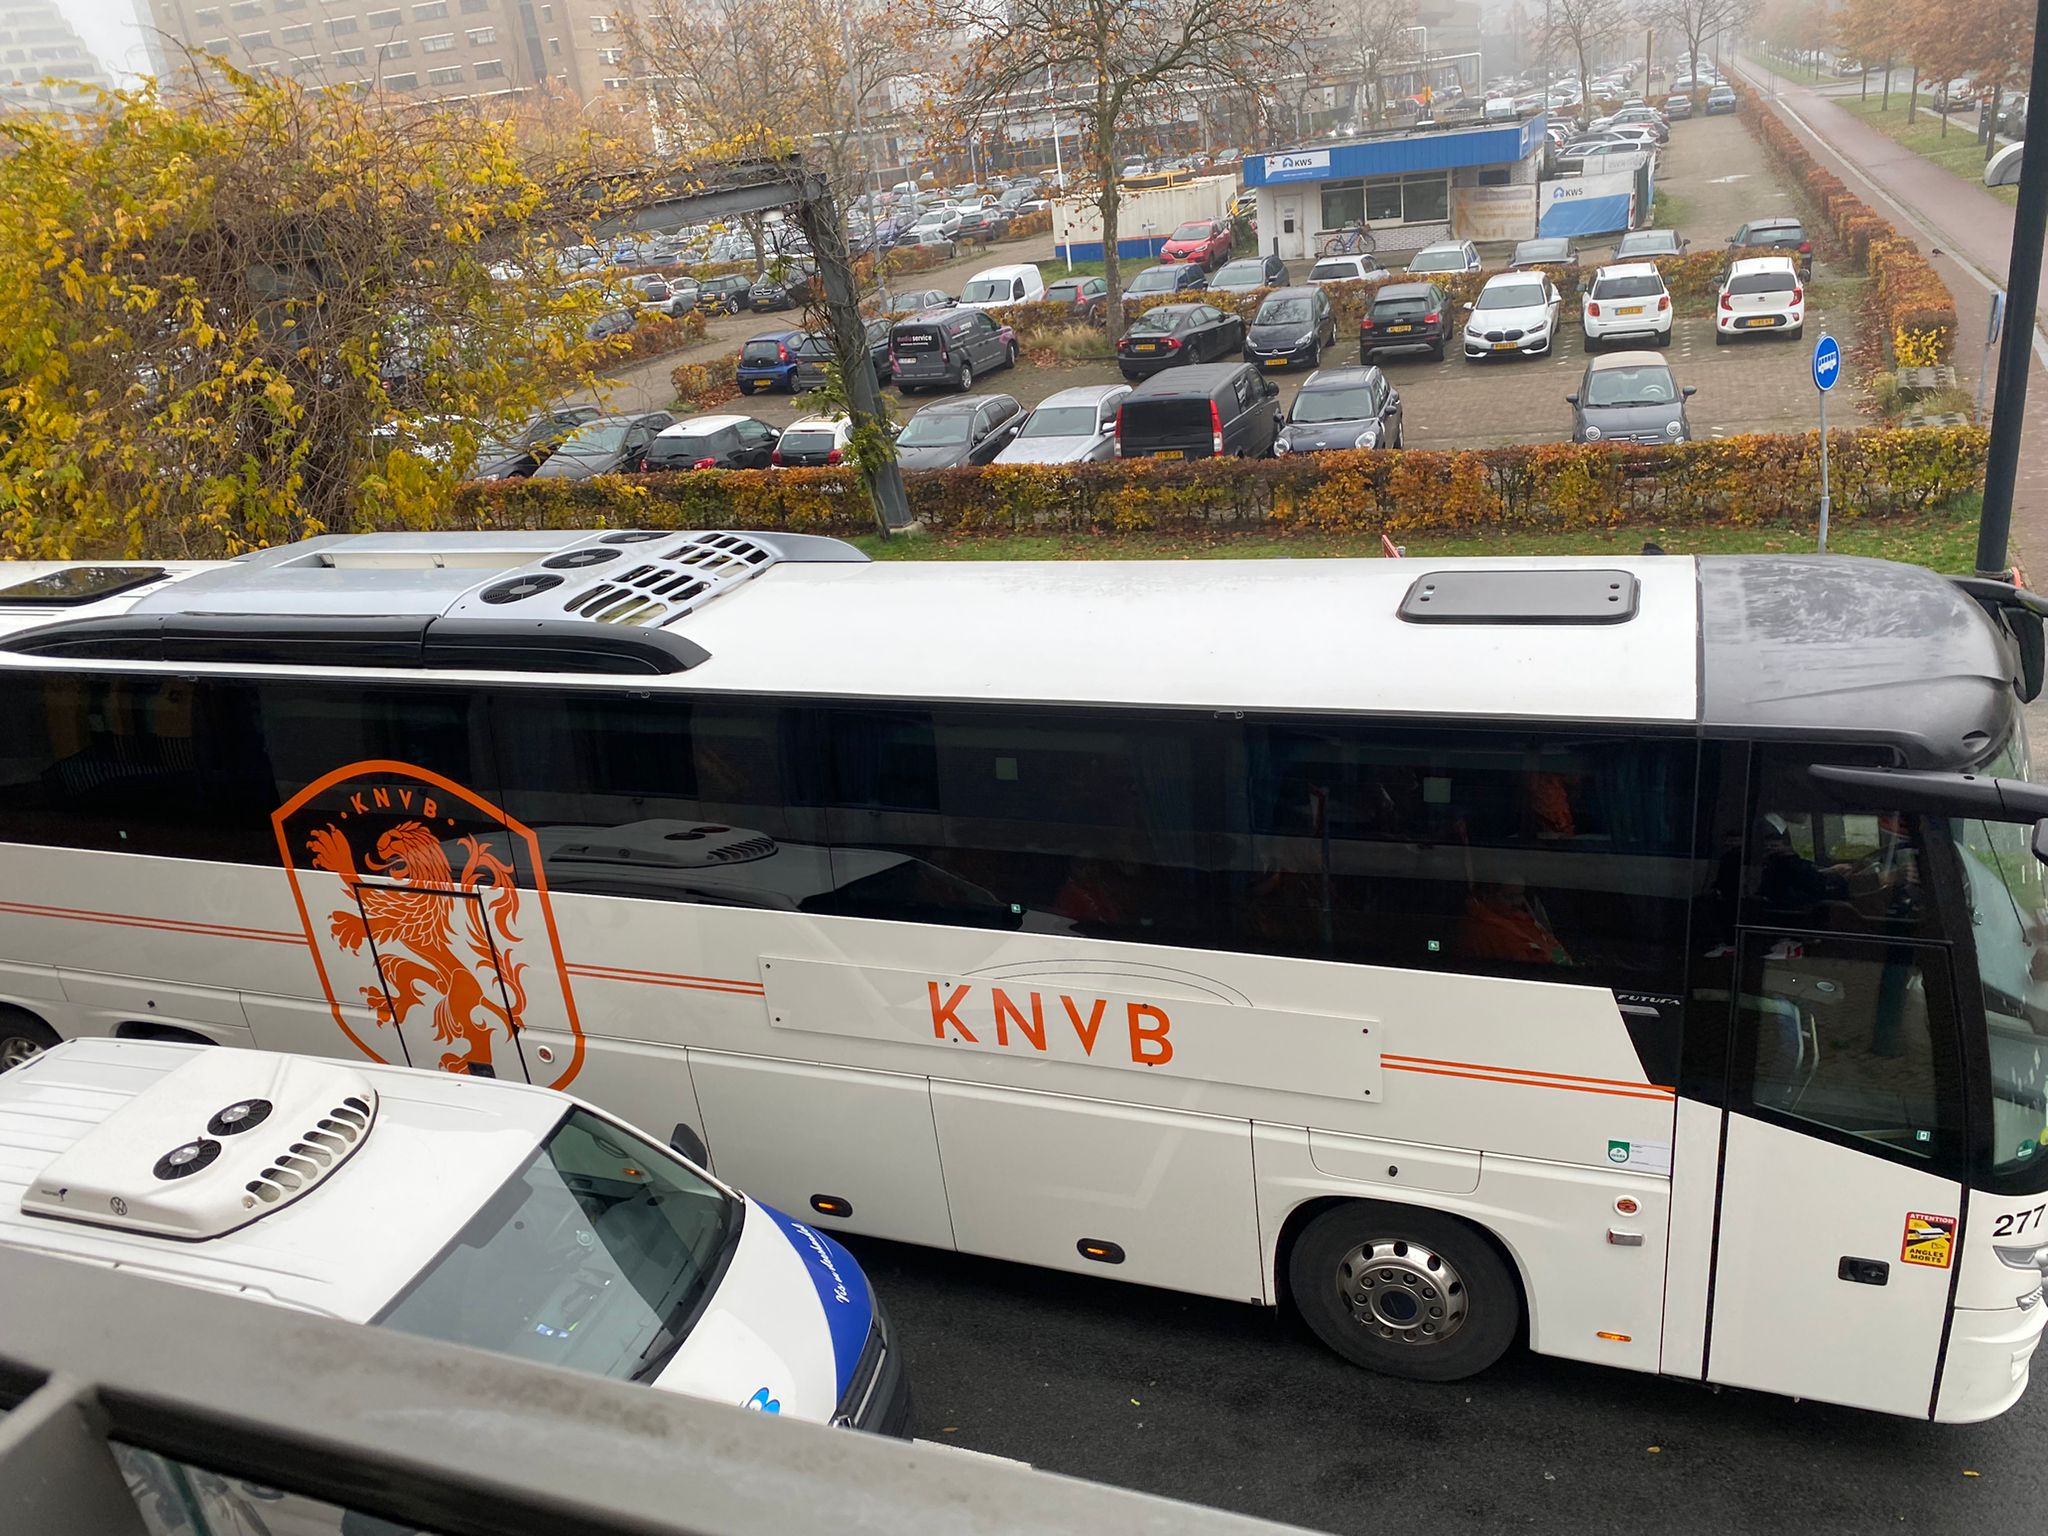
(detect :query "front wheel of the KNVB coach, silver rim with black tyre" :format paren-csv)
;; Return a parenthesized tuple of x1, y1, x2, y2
(1288, 1202, 1522, 1380)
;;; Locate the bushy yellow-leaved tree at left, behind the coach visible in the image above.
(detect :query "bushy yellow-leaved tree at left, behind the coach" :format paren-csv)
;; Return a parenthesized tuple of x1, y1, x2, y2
(0, 59, 647, 557)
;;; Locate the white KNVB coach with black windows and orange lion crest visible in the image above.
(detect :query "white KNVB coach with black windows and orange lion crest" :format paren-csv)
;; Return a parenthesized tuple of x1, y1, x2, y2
(0, 530, 2048, 1421)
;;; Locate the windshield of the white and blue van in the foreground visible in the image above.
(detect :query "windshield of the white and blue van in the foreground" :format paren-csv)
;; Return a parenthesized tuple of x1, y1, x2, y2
(377, 1110, 739, 1380)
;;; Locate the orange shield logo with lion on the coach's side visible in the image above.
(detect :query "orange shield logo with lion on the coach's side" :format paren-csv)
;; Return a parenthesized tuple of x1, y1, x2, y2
(270, 762, 584, 1087)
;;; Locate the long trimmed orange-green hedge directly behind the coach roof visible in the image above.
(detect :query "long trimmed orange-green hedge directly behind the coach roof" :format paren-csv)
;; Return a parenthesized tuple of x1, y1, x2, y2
(449, 426, 1987, 537)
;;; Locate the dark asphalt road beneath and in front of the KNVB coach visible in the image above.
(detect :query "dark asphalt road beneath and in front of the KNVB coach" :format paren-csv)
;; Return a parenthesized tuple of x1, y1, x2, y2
(848, 1237, 2048, 1536)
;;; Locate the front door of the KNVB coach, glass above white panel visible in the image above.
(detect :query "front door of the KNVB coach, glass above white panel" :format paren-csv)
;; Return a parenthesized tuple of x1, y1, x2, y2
(1706, 794, 1966, 1417)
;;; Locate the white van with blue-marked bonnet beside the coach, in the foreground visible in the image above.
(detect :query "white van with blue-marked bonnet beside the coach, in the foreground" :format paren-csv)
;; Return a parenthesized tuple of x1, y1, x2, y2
(0, 1038, 909, 1432)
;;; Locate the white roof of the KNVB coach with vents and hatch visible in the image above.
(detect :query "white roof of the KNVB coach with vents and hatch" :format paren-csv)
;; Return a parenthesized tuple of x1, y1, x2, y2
(0, 530, 2013, 760)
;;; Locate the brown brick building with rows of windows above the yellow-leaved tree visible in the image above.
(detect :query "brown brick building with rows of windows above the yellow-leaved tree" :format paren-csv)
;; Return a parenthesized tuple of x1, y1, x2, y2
(146, 0, 627, 100)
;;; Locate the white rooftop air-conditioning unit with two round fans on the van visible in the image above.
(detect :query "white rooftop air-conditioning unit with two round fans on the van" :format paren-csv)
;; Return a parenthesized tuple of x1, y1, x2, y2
(20, 1047, 377, 1241)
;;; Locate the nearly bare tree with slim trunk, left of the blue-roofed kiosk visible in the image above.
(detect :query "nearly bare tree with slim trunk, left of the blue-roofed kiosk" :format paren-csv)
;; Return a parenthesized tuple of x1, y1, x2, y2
(918, 0, 1309, 342)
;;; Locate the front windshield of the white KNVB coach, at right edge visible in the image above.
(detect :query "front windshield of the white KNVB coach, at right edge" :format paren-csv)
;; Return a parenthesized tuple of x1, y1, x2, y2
(1950, 721, 2048, 1190)
